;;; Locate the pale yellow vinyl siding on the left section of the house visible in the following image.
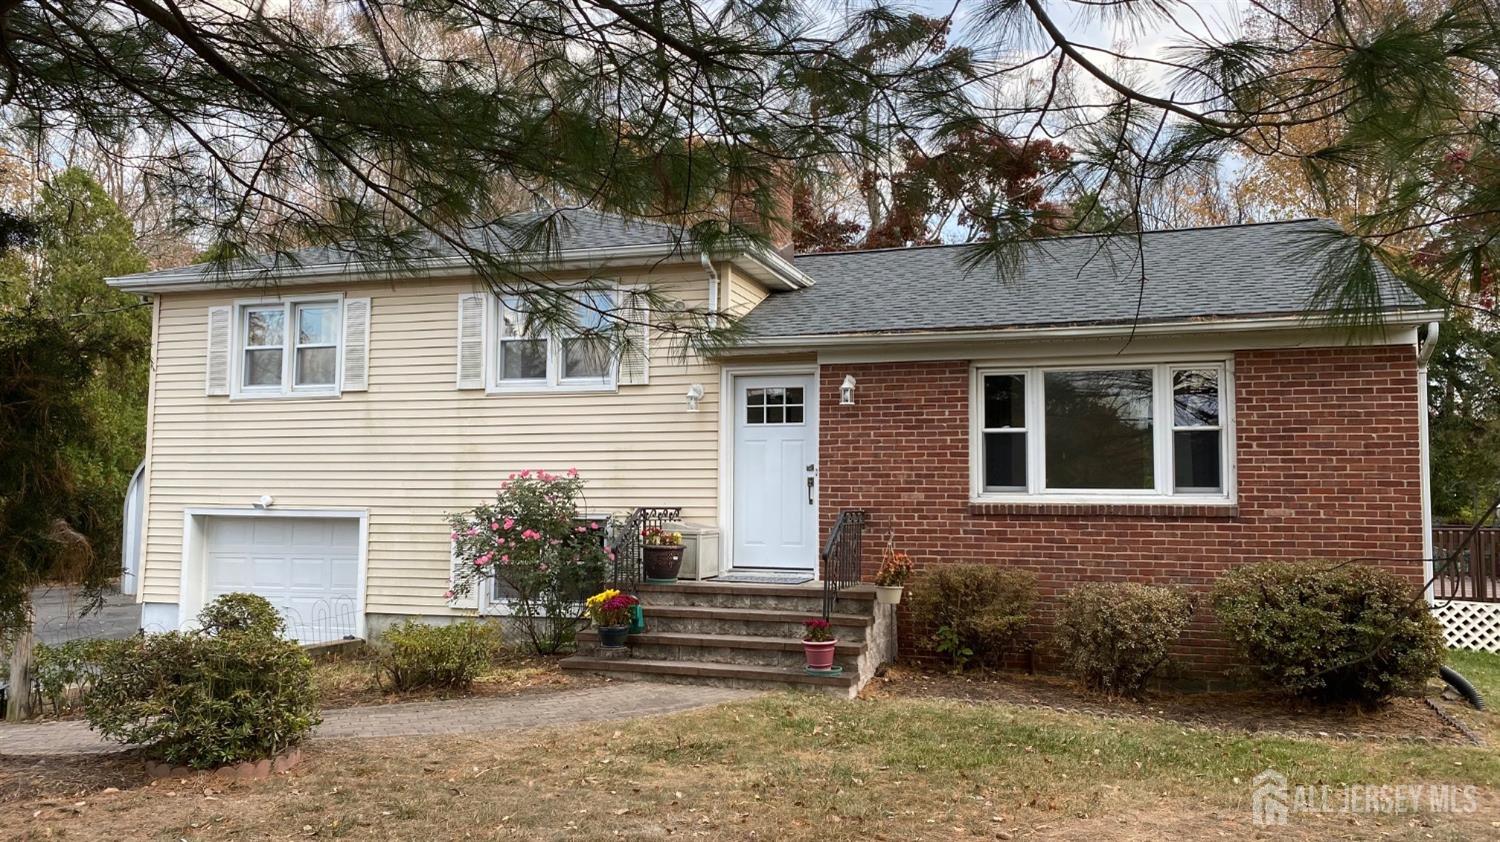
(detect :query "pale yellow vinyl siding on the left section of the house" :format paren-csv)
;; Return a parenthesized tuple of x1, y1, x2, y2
(141, 267, 719, 614)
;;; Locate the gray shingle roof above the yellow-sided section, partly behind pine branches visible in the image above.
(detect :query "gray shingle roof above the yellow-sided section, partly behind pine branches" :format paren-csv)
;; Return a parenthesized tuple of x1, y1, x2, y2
(111, 209, 690, 281)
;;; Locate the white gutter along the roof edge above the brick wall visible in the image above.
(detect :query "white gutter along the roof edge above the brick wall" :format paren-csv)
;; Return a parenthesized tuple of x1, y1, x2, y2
(726, 311, 1443, 353)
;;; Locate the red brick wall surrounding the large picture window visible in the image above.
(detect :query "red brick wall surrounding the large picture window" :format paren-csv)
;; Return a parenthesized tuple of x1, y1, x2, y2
(819, 345, 1422, 678)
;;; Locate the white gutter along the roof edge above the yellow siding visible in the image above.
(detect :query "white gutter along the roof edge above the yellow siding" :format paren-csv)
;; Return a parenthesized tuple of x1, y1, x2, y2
(105, 243, 812, 293)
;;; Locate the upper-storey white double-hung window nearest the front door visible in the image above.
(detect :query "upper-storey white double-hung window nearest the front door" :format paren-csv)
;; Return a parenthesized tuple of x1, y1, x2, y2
(494, 290, 618, 390)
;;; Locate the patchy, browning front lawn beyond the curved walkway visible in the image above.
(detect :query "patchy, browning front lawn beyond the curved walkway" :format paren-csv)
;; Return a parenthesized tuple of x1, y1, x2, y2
(0, 684, 1500, 842)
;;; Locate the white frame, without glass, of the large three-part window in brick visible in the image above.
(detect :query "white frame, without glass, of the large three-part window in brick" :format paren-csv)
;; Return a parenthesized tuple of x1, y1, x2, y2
(969, 357, 1236, 506)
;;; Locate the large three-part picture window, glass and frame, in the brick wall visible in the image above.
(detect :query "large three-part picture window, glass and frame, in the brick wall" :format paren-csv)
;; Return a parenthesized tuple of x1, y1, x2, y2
(974, 362, 1233, 501)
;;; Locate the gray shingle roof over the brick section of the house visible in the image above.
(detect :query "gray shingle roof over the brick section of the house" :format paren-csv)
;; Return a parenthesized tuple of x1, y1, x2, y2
(743, 219, 1422, 336)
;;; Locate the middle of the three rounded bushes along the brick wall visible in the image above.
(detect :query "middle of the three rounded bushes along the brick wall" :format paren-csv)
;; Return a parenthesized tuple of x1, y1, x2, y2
(1056, 582, 1193, 696)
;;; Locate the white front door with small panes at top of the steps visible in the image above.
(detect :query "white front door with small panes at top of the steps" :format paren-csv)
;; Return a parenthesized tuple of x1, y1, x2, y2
(731, 374, 818, 572)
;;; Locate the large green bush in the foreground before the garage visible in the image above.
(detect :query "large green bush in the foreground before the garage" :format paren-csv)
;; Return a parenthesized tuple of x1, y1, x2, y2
(84, 597, 320, 768)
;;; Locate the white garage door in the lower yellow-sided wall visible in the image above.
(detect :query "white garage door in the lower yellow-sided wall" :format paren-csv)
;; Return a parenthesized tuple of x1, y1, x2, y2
(204, 518, 360, 644)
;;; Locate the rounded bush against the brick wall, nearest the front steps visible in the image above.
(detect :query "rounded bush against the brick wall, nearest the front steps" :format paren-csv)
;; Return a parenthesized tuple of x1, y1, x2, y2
(912, 564, 1037, 669)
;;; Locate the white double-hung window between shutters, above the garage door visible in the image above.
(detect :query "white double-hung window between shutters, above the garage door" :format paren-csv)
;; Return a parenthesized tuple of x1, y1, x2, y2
(236, 299, 342, 396)
